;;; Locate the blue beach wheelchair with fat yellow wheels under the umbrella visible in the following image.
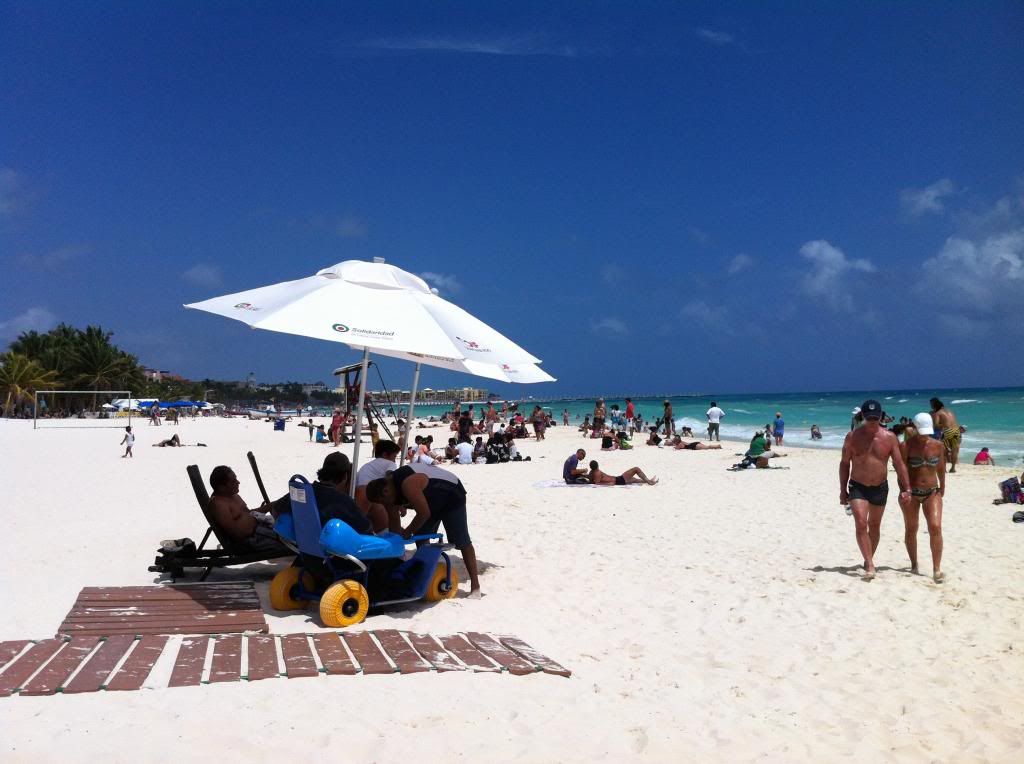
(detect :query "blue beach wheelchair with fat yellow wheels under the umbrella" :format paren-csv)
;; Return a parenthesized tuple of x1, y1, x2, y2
(270, 475, 459, 628)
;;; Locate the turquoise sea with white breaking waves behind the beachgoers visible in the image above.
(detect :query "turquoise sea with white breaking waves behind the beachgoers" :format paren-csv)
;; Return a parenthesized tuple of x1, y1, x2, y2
(399, 387, 1024, 465)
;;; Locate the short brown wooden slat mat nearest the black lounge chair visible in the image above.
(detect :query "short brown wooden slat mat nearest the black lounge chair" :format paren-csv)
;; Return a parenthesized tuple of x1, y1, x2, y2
(57, 582, 267, 637)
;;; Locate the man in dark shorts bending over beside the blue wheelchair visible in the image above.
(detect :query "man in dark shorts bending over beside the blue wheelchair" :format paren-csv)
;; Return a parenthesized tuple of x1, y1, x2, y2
(367, 464, 480, 599)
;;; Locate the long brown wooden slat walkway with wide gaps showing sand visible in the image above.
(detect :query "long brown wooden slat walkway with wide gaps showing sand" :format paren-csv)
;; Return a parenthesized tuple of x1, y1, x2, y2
(0, 629, 570, 697)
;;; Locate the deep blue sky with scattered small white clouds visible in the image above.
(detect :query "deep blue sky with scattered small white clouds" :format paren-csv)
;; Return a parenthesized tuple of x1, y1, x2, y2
(0, 0, 1024, 394)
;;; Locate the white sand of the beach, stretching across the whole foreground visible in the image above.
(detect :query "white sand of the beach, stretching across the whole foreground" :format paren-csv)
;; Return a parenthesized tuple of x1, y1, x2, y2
(0, 419, 1024, 762)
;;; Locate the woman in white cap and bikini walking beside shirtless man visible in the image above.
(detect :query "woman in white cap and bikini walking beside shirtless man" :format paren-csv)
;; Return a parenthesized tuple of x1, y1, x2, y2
(899, 414, 946, 584)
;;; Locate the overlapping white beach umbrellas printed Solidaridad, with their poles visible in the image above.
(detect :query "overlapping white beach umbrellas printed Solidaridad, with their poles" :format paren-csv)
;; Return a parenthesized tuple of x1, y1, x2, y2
(185, 259, 553, 493)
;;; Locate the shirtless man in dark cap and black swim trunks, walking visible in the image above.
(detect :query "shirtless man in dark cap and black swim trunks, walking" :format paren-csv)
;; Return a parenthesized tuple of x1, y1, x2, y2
(839, 400, 910, 581)
